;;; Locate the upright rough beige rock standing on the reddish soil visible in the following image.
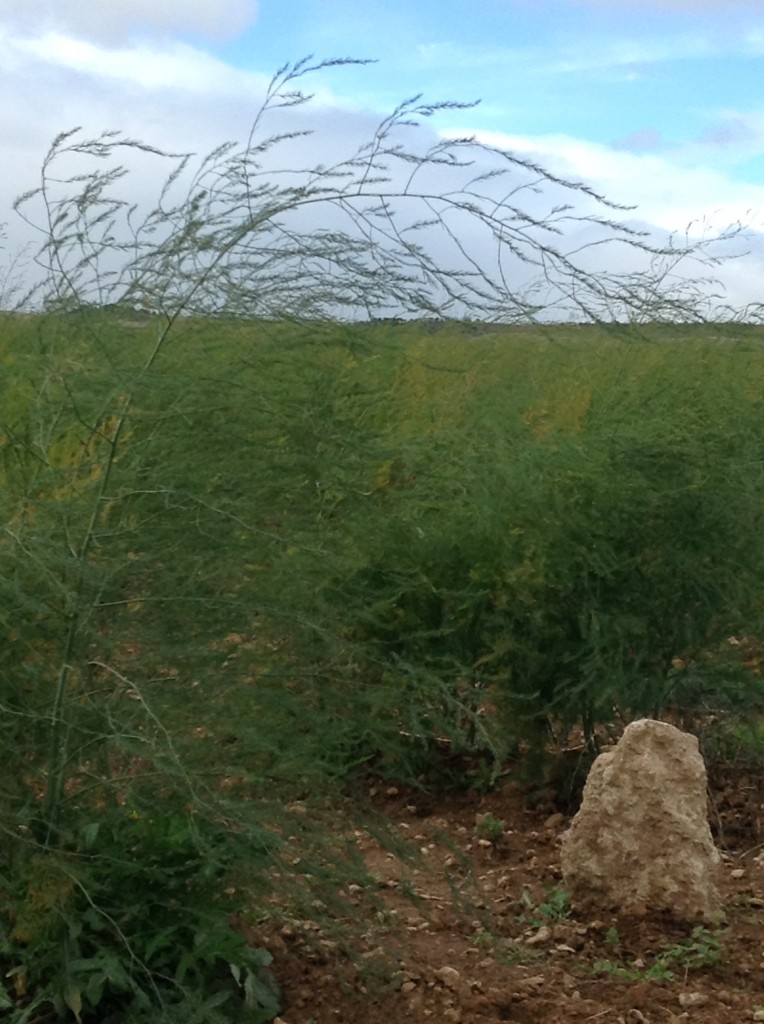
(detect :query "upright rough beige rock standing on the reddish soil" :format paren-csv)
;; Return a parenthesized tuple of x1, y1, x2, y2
(562, 719, 721, 921)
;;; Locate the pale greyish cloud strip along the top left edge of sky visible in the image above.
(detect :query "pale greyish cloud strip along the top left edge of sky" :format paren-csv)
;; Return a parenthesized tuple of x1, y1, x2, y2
(0, 0, 257, 43)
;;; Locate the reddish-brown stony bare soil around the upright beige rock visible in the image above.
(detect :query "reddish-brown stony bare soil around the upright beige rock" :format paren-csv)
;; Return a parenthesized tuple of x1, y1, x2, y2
(256, 769, 764, 1024)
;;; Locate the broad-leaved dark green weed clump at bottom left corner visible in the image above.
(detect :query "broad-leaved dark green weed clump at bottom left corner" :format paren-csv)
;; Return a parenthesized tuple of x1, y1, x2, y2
(1, 806, 281, 1024)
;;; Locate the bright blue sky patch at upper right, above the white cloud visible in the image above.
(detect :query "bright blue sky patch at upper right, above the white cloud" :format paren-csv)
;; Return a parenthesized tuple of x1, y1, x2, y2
(209, 0, 764, 183)
